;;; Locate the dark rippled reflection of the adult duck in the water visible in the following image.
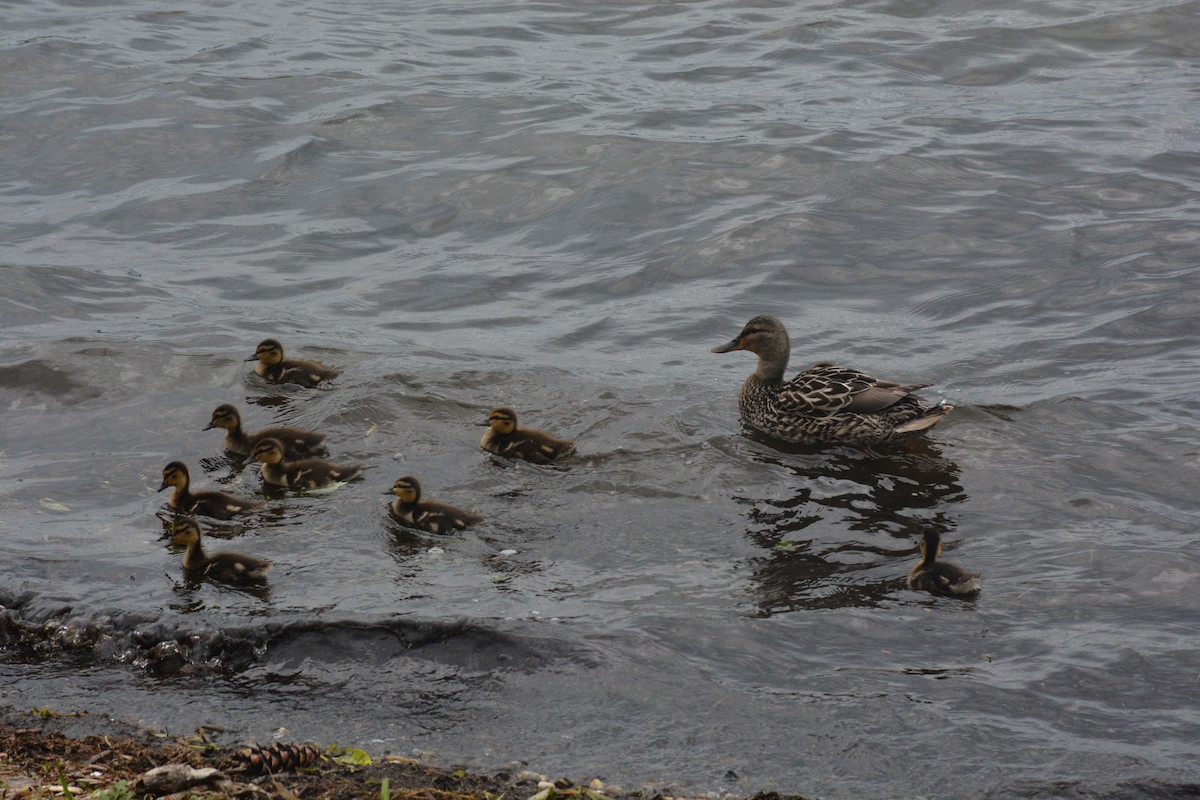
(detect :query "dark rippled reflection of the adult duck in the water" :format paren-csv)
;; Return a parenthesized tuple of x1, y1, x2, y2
(734, 440, 967, 616)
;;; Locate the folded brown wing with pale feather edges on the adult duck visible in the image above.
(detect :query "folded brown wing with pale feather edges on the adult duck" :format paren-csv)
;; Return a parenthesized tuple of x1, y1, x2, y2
(773, 361, 929, 414)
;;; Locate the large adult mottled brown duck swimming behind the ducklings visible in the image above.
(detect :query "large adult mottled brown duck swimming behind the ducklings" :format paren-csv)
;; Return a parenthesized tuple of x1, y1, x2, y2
(713, 314, 954, 447)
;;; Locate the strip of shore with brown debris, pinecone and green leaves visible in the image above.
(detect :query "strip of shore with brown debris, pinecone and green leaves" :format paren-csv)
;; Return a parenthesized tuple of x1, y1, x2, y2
(0, 705, 804, 800)
